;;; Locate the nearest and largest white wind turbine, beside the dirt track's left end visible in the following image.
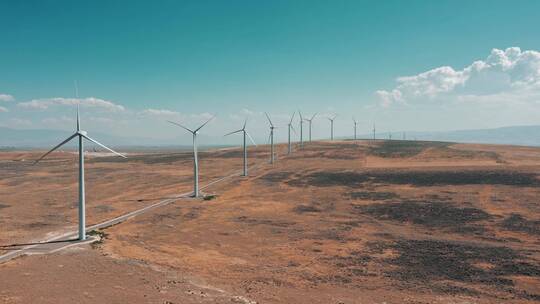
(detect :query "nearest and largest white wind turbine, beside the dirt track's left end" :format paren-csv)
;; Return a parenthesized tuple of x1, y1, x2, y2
(34, 104, 126, 241)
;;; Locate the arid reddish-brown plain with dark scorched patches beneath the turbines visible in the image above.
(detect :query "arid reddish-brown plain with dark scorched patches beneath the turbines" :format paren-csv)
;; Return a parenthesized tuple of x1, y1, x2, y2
(0, 141, 540, 304)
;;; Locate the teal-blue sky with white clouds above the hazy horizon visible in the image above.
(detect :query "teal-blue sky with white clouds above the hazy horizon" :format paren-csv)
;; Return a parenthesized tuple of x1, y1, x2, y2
(0, 1, 540, 142)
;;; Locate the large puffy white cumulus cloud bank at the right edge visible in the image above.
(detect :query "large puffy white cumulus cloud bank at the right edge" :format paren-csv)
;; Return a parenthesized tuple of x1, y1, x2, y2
(375, 47, 540, 107)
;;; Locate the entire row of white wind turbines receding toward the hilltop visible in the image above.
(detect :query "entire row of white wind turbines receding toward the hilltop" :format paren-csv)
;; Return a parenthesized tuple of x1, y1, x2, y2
(34, 88, 400, 241)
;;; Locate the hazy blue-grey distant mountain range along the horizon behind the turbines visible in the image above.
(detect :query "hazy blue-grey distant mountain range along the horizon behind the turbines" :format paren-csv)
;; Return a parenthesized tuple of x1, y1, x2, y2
(0, 126, 540, 149)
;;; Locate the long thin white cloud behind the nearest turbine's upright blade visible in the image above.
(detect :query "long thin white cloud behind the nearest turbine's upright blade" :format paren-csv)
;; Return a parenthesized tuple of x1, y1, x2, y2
(18, 97, 125, 112)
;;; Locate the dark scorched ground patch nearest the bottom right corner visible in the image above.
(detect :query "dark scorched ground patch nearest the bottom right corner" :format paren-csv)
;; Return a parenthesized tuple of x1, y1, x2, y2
(377, 240, 540, 298)
